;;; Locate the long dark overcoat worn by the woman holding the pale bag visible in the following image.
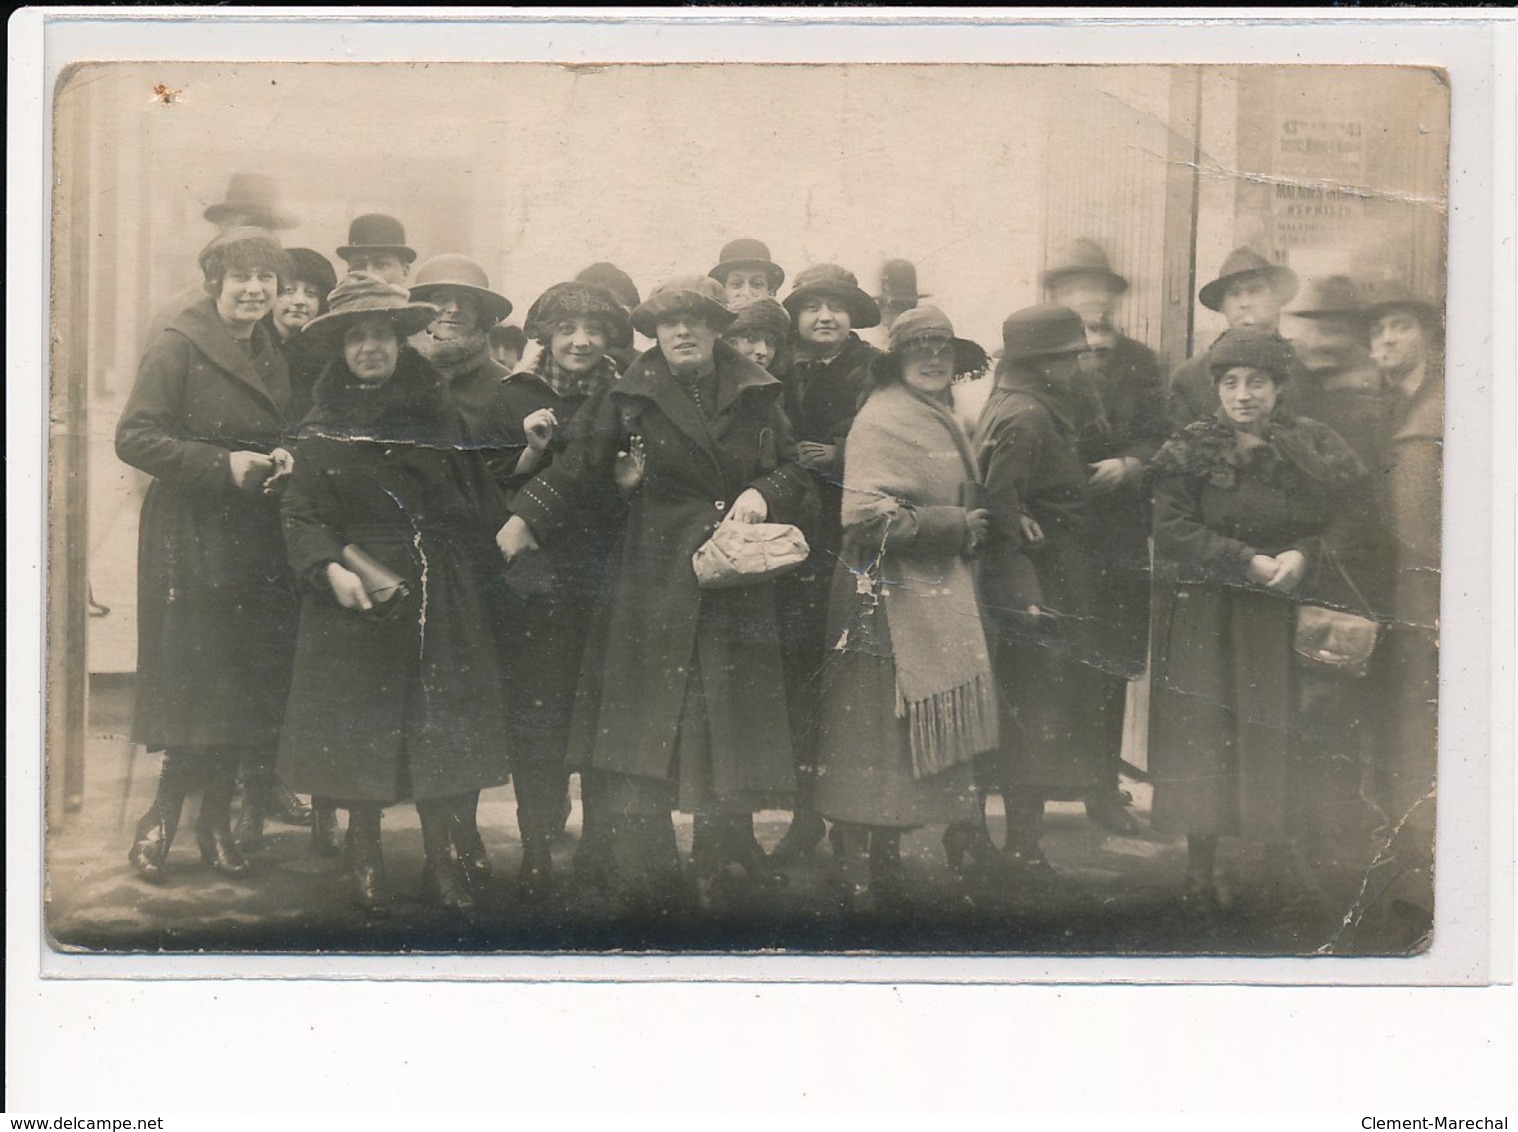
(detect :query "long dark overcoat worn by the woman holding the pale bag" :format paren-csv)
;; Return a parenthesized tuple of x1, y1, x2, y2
(515, 341, 814, 795)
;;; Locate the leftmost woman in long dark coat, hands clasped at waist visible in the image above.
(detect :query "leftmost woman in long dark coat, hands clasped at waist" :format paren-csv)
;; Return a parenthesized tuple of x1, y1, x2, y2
(115, 228, 296, 879)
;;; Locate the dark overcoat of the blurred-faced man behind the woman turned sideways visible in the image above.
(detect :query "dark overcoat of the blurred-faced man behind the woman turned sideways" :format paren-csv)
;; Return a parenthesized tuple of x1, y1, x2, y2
(1079, 335, 1170, 678)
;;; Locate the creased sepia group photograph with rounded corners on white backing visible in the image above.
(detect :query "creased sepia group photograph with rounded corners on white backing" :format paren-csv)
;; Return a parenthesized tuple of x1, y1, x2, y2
(44, 62, 1451, 959)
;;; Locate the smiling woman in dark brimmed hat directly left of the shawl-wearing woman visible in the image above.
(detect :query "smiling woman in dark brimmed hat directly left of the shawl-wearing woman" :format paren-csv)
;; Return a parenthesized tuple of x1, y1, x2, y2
(774, 264, 880, 863)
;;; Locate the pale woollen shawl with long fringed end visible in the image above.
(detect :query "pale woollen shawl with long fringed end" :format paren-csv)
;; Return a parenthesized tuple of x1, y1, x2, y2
(838, 382, 997, 778)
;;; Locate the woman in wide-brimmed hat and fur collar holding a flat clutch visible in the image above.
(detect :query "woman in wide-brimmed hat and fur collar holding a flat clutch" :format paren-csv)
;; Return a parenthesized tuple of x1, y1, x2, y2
(279, 273, 507, 910)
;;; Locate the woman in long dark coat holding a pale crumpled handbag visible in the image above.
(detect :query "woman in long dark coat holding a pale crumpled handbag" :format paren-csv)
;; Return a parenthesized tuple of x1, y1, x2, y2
(498, 276, 812, 910)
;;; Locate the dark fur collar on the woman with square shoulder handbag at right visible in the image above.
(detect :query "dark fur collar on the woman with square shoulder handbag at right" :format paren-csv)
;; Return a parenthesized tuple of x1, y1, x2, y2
(1149, 407, 1366, 492)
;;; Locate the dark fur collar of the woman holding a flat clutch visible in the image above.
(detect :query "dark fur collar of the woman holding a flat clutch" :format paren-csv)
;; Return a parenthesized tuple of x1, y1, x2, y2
(301, 343, 460, 448)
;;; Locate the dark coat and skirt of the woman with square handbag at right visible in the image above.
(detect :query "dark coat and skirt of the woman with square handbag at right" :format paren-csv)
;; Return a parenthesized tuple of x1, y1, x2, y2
(1149, 419, 1363, 841)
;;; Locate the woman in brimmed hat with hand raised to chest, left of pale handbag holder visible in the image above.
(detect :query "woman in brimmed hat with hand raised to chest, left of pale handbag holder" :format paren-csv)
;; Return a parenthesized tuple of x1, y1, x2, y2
(493, 282, 633, 898)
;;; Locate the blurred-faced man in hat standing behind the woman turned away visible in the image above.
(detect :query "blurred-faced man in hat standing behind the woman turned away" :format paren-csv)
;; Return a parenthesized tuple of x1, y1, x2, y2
(1043, 238, 1169, 836)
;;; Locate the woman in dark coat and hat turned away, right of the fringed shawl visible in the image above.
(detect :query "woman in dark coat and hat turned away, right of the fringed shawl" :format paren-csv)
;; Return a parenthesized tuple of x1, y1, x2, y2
(971, 305, 1125, 883)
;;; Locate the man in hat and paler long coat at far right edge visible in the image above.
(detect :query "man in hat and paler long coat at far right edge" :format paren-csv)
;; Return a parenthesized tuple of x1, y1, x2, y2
(1363, 282, 1444, 944)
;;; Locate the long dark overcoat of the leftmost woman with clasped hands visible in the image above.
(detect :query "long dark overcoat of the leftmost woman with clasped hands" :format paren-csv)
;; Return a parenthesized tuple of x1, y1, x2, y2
(115, 297, 296, 750)
